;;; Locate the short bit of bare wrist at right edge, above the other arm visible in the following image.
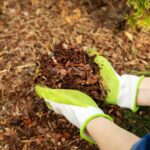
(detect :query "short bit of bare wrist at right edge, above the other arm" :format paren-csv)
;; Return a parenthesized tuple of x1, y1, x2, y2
(137, 78, 150, 106)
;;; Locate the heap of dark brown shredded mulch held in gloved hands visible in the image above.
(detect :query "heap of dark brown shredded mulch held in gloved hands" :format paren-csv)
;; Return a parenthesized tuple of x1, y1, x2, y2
(35, 42, 106, 102)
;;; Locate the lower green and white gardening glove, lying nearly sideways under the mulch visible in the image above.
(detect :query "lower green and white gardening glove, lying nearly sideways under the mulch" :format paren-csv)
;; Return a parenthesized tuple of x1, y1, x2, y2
(35, 85, 112, 143)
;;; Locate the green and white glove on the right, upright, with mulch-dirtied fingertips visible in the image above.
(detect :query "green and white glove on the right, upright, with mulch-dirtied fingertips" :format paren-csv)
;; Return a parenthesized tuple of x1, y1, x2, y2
(86, 48, 144, 112)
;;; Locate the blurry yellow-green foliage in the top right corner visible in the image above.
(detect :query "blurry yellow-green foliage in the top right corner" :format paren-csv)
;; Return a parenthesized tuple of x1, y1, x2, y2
(127, 0, 150, 31)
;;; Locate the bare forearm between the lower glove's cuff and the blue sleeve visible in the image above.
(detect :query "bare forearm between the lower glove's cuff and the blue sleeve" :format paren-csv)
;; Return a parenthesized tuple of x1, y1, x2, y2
(87, 117, 139, 150)
